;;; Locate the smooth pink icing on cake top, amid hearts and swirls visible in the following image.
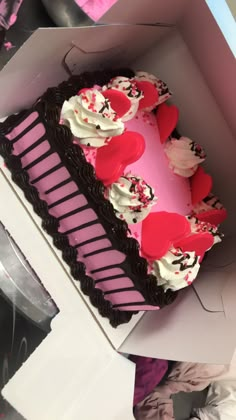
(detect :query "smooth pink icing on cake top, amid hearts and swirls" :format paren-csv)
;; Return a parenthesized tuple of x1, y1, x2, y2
(126, 111, 192, 238)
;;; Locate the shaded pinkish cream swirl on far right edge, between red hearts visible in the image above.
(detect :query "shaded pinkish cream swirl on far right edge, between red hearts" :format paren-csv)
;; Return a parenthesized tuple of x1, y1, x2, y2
(164, 137, 206, 178)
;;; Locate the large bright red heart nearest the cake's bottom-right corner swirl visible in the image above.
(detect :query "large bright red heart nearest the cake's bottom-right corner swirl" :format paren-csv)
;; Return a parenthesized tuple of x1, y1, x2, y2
(141, 211, 190, 261)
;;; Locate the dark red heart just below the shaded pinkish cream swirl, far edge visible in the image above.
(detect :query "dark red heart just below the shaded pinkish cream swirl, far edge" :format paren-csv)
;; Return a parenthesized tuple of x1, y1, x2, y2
(190, 166, 212, 205)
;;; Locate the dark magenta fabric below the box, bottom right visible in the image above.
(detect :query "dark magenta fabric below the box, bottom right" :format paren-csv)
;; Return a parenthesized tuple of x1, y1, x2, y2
(130, 356, 168, 405)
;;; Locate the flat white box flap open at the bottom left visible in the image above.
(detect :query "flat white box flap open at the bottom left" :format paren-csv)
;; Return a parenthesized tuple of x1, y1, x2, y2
(2, 316, 135, 420)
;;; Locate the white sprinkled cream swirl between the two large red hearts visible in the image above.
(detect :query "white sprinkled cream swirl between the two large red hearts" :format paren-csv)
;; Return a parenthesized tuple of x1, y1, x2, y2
(107, 175, 157, 224)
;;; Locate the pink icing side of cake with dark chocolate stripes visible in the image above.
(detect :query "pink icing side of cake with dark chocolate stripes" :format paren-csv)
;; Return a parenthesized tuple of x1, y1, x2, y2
(7, 112, 158, 310)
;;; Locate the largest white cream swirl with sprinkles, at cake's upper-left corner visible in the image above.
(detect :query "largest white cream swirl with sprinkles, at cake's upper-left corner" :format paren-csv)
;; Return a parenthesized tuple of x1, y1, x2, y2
(61, 89, 124, 147)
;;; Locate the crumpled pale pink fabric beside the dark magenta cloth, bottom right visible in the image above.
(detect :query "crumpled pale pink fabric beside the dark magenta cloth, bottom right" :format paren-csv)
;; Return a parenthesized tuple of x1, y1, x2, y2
(135, 363, 229, 420)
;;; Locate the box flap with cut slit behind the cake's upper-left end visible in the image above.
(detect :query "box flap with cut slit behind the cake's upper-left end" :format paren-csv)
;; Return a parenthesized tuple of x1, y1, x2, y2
(0, 25, 169, 117)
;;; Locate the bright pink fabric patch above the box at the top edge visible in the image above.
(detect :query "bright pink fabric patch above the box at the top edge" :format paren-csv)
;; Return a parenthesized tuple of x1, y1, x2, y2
(75, 0, 117, 22)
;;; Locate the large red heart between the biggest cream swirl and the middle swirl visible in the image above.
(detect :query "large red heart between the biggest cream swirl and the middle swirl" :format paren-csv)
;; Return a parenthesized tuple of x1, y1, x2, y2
(95, 131, 145, 185)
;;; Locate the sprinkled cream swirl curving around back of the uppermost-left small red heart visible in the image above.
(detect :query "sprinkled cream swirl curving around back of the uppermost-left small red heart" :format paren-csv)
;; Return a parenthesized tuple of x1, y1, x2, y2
(102, 76, 143, 121)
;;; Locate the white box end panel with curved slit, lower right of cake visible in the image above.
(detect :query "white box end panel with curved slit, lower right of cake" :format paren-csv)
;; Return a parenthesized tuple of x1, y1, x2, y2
(120, 237, 236, 364)
